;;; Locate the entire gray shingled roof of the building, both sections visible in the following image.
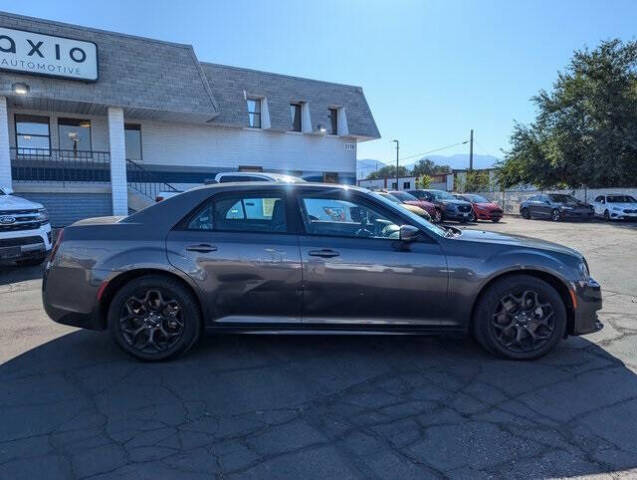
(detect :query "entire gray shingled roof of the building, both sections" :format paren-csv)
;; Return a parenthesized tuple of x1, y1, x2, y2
(0, 12, 380, 138)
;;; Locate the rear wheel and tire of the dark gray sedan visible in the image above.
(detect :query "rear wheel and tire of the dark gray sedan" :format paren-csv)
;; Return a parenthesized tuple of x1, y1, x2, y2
(108, 275, 201, 361)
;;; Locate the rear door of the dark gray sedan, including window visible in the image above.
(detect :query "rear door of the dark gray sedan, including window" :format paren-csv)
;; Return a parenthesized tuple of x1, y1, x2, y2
(167, 188, 302, 324)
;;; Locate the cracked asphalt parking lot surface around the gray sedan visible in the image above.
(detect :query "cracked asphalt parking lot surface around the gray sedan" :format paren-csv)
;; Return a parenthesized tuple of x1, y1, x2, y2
(0, 217, 637, 480)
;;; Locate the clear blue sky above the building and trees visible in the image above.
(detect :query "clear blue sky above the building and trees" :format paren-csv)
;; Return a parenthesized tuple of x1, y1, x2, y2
(0, 0, 637, 165)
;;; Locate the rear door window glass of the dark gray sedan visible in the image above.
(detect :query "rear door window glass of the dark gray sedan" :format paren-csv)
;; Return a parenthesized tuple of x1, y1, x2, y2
(187, 195, 287, 233)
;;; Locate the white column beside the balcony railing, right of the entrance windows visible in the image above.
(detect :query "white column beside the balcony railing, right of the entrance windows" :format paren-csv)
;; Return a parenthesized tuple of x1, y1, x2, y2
(108, 107, 128, 215)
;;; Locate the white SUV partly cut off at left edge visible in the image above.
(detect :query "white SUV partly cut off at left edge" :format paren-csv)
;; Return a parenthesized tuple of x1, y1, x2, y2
(0, 187, 51, 265)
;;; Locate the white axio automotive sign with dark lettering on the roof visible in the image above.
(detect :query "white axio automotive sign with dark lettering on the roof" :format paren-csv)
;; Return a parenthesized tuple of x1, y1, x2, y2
(0, 27, 97, 82)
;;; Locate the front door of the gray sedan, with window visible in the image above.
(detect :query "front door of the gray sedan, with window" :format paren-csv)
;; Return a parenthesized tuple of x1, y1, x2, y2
(297, 189, 448, 326)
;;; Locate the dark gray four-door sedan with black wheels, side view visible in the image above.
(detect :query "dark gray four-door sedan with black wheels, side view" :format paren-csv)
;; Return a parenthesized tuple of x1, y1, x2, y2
(42, 182, 601, 360)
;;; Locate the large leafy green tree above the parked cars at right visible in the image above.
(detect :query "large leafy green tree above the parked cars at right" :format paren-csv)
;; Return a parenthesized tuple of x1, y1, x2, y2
(498, 40, 637, 188)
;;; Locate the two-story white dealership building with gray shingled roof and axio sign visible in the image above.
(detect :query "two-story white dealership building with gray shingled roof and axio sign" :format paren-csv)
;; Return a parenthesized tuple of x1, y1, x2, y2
(0, 12, 379, 225)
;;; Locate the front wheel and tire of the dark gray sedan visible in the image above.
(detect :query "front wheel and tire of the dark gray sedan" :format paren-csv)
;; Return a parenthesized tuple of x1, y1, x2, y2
(472, 274, 566, 360)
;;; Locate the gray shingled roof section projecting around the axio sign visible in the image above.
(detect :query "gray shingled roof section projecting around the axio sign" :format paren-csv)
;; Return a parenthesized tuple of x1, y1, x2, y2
(0, 12, 218, 122)
